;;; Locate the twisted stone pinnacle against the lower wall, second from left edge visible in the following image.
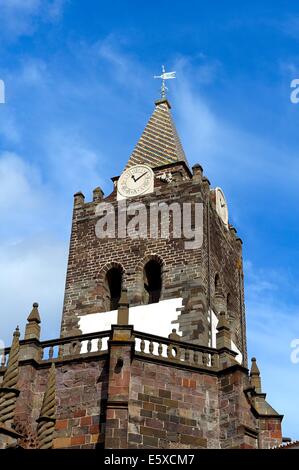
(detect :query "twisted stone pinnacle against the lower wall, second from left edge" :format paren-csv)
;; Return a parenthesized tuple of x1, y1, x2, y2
(37, 363, 56, 449)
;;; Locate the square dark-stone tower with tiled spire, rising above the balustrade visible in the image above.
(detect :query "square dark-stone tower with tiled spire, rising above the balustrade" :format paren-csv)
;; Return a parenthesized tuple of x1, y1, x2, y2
(61, 99, 247, 365)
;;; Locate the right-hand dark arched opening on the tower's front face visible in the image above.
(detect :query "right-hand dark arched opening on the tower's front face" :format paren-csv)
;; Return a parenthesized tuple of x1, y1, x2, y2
(143, 259, 162, 304)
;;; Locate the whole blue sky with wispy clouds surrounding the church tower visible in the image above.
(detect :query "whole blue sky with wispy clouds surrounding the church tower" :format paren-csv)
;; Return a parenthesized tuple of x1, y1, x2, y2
(0, 0, 299, 438)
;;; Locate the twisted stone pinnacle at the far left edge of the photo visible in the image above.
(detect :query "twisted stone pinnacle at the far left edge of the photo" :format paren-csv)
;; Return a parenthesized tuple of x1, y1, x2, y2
(0, 326, 20, 423)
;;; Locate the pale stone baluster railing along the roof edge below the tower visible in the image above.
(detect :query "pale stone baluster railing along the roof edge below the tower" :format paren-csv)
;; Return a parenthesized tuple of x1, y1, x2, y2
(0, 330, 219, 369)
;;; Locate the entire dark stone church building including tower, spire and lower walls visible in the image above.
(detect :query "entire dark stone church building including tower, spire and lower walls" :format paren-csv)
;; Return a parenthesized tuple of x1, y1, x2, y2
(0, 94, 282, 449)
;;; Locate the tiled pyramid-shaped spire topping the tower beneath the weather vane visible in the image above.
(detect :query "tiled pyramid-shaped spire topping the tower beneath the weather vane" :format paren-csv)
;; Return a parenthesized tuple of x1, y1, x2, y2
(127, 99, 188, 168)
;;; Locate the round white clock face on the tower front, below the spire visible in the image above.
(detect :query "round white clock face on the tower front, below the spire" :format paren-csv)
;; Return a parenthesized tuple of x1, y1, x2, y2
(117, 165, 154, 199)
